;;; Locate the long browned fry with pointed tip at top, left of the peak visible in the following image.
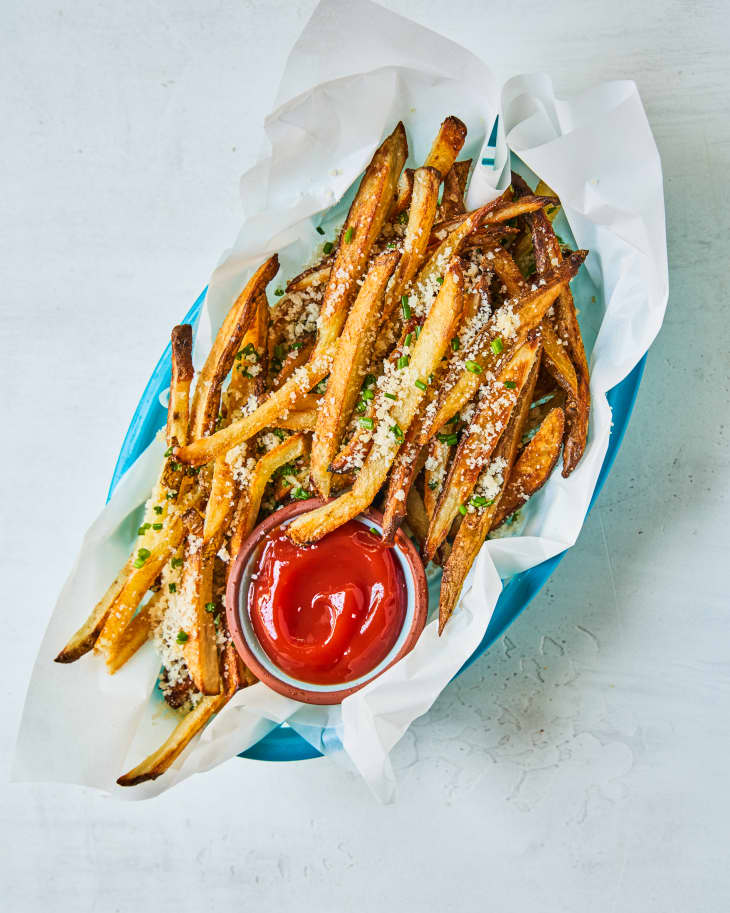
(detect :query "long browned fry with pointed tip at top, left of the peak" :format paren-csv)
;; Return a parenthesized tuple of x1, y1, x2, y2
(313, 123, 408, 352)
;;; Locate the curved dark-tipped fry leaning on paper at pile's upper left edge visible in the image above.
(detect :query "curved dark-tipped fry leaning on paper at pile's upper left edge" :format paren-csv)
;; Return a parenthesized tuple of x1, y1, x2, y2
(190, 255, 279, 440)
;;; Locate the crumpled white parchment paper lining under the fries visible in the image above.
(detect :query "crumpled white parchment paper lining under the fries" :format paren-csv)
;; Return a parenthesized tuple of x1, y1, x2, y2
(14, 0, 668, 801)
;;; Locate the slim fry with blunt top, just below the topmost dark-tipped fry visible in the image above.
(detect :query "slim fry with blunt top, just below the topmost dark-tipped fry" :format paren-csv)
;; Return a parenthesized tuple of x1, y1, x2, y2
(376, 168, 441, 326)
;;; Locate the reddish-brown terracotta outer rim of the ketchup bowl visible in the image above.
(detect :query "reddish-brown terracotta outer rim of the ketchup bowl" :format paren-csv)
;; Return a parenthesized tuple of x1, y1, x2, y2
(226, 498, 428, 704)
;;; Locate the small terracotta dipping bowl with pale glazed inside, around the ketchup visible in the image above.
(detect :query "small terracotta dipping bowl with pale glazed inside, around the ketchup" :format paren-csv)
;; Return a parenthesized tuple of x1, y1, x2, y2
(226, 498, 428, 704)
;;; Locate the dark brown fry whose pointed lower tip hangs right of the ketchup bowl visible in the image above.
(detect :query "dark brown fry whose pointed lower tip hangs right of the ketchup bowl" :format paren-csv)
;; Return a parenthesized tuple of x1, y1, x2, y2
(439, 350, 537, 635)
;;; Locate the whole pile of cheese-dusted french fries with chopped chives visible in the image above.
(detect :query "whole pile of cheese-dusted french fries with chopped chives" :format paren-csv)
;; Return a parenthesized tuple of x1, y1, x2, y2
(57, 117, 590, 786)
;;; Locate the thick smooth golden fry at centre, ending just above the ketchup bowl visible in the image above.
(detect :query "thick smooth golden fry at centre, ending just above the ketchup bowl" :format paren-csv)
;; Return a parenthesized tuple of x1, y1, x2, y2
(310, 248, 398, 498)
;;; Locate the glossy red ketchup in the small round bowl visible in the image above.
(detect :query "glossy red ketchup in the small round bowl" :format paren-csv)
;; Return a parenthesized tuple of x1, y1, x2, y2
(248, 520, 406, 685)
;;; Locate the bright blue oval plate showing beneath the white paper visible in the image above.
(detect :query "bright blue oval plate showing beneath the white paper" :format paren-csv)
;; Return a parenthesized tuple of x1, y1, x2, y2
(107, 289, 646, 761)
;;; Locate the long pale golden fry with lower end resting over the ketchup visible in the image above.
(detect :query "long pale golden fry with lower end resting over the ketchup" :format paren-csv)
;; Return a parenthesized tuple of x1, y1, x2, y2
(288, 258, 464, 545)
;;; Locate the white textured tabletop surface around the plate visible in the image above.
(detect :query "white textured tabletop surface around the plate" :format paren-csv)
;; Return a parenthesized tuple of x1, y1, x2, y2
(0, 0, 730, 913)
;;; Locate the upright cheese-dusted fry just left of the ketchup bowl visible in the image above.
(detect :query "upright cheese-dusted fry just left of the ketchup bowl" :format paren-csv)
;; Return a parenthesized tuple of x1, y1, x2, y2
(179, 508, 221, 694)
